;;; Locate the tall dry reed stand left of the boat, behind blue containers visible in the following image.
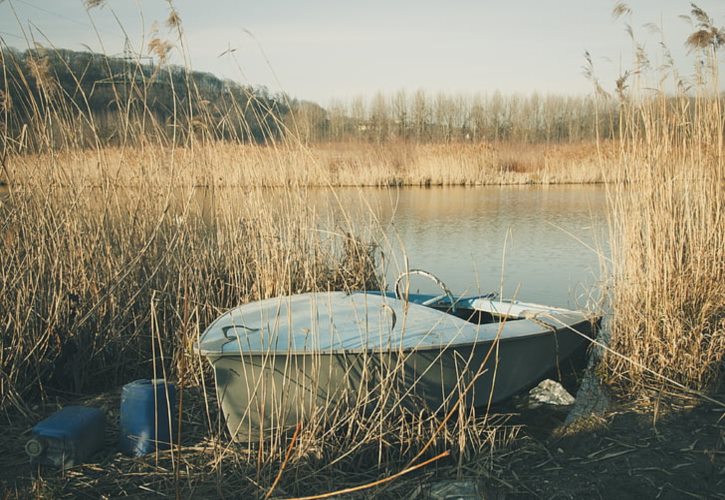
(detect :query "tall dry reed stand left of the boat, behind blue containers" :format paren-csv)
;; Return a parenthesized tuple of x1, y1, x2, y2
(0, 2, 378, 418)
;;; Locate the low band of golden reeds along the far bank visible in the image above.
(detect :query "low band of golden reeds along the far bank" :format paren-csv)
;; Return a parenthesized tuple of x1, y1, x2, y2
(8, 142, 616, 187)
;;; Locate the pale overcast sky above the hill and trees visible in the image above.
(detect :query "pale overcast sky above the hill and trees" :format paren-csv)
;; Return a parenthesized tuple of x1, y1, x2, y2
(0, 0, 725, 106)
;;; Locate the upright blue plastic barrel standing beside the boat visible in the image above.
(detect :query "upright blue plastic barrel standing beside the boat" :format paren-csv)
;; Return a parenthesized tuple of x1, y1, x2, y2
(119, 379, 178, 457)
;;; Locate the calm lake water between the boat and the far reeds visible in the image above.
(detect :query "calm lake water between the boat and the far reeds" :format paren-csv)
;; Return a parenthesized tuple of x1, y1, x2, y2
(313, 185, 608, 307)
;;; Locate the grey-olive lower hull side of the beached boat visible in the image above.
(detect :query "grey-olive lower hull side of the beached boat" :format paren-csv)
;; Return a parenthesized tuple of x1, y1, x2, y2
(208, 320, 596, 442)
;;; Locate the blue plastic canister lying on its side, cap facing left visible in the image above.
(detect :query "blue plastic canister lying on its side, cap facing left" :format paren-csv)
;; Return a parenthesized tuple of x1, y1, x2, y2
(25, 406, 106, 469)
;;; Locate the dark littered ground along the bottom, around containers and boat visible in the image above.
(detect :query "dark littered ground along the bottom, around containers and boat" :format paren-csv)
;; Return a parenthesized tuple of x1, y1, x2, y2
(0, 380, 725, 498)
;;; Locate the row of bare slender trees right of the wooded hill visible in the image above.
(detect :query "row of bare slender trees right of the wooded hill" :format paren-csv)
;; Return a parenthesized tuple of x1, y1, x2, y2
(294, 90, 618, 143)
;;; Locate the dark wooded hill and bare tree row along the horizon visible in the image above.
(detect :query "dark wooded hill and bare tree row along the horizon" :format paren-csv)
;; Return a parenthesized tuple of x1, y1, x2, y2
(0, 47, 618, 149)
